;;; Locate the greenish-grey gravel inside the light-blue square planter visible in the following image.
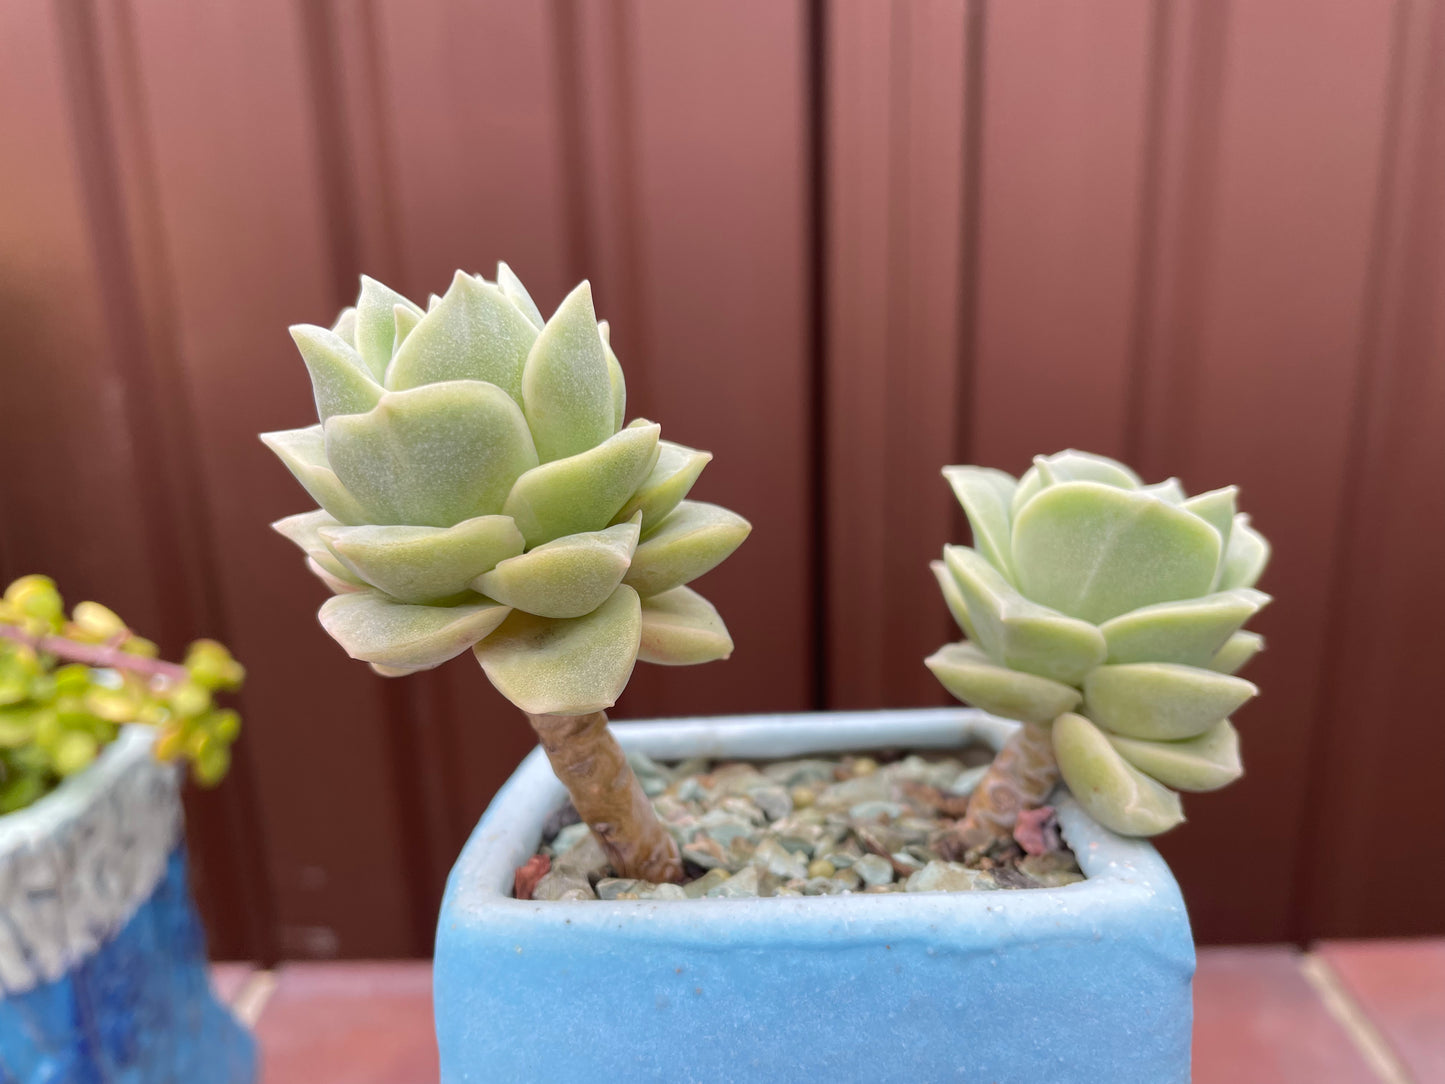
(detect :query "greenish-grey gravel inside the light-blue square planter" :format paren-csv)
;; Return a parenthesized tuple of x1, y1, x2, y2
(514, 746, 1084, 900)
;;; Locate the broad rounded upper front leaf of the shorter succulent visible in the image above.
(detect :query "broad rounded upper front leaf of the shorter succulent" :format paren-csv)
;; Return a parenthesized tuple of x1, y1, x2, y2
(1013, 481, 1220, 624)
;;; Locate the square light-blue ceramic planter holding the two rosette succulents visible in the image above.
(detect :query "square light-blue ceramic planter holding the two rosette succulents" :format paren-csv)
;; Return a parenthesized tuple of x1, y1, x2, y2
(435, 708, 1194, 1084)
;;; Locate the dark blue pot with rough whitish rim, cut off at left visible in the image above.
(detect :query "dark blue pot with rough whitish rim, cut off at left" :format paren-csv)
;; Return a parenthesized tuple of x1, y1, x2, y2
(0, 727, 256, 1084)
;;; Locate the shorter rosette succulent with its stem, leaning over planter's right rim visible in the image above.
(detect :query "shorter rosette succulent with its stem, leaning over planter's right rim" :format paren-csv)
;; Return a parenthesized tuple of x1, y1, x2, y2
(928, 451, 1269, 853)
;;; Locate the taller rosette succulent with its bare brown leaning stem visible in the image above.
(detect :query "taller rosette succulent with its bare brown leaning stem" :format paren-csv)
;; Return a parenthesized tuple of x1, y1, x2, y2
(262, 263, 750, 882)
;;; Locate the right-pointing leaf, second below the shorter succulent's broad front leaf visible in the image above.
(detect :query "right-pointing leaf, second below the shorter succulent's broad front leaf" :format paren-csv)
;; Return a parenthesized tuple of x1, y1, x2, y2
(1084, 662, 1259, 741)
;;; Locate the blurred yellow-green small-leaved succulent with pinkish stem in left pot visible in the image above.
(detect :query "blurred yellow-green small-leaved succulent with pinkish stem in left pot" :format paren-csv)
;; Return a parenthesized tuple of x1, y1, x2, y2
(0, 575, 246, 814)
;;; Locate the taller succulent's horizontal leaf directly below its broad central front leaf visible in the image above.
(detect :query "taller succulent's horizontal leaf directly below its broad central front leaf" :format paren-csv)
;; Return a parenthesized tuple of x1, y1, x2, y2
(321, 516, 523, 603)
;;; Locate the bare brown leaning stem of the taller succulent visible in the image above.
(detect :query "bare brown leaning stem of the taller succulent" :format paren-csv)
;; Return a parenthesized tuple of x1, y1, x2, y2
(527, 711, 682, 885)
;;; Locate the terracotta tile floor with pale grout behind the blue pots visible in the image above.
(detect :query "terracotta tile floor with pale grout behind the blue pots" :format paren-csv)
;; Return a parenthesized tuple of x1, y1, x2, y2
(217, 939, 1445, 1084)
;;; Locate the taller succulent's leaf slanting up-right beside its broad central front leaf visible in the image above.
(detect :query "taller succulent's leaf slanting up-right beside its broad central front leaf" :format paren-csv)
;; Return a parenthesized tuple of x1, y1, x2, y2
(501, 422, 662, 546)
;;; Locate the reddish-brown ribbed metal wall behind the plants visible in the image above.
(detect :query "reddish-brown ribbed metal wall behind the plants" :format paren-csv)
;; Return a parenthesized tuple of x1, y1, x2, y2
(0, 0, 1445, 957)
